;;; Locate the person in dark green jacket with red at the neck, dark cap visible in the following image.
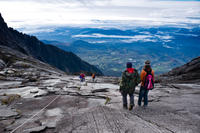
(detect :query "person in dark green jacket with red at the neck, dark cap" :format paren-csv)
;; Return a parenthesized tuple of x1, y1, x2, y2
(120, 62, 140, 110)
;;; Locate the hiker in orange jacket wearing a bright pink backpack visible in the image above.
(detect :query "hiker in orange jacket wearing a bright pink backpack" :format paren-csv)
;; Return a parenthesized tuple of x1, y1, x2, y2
(138, 60, 154, 107)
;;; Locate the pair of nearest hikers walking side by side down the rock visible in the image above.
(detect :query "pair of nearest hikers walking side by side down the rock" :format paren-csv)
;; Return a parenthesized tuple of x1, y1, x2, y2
(120, 60, 154, 110)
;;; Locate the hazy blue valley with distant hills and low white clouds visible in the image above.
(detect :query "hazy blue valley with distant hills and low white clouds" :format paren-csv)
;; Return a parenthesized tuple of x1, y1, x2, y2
(36, 25, 200, 76)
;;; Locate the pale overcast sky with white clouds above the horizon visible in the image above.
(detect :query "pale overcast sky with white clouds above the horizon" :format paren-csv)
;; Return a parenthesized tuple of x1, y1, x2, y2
(0, 0, 200, 28)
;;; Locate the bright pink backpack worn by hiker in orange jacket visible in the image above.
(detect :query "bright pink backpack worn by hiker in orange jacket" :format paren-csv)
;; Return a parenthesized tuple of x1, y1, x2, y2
(144, 71, 154, 90)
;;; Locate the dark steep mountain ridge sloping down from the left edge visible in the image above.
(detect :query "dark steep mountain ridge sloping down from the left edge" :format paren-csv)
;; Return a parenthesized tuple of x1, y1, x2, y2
(0, 14, 102, 75)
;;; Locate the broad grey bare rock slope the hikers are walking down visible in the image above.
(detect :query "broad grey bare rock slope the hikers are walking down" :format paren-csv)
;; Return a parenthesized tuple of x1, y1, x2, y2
(0, 47, 200, 133)
